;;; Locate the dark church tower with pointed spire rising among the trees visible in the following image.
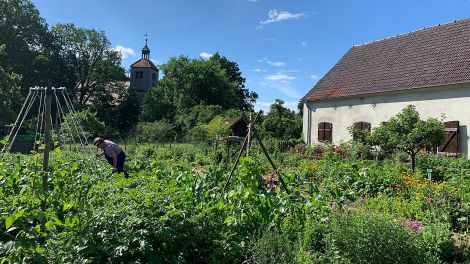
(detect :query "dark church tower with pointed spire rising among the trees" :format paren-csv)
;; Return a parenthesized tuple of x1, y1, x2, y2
(130, 36, 160, 93)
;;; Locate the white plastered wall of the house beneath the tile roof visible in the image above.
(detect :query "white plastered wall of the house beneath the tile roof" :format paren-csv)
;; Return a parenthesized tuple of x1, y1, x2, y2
(303, 84, 470, 157)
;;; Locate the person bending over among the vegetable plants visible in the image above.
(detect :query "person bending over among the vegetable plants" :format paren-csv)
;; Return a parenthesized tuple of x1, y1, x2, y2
(93, 137, 129, 178)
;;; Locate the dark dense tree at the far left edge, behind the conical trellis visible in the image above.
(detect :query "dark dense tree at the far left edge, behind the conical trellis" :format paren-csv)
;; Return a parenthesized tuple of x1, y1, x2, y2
(0, 0, 56, 134)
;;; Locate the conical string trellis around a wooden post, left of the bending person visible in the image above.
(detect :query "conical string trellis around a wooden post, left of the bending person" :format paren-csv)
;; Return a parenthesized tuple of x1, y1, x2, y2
(1, 87, 101, 210)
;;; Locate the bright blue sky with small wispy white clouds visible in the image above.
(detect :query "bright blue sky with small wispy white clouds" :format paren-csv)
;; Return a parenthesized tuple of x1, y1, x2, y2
(32, 0, 470, 110)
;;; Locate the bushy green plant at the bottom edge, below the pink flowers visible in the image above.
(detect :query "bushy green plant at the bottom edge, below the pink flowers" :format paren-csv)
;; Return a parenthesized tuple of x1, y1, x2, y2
(326, 211, 432, 263)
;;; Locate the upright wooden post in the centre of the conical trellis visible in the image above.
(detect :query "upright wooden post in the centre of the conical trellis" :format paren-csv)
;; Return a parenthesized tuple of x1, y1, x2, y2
(41, 88, 52, 211)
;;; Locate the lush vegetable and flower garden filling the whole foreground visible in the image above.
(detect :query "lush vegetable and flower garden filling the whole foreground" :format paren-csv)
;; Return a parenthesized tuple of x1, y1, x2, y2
(0, 142, 470, 263)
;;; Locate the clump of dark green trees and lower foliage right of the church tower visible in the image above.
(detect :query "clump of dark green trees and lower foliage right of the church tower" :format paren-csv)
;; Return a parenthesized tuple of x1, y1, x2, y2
(142, 53, 258, 135)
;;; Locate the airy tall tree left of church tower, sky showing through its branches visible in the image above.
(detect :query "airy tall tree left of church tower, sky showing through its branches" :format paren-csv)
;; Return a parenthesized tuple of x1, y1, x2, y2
(52, 24, 125, 105)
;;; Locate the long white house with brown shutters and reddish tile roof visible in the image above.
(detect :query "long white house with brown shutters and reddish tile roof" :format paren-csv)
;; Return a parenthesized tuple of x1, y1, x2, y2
(302, 19, 470, 157)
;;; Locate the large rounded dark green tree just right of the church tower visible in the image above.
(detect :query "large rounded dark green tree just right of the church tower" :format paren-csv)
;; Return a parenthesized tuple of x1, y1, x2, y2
(159, 55, 256, 114)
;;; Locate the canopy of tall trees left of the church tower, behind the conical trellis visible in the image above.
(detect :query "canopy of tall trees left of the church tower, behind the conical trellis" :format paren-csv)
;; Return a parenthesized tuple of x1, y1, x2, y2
(0, 0, 126, 136)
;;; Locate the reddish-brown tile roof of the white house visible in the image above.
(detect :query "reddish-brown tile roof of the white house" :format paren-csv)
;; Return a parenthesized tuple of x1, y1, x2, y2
(302, 19, 470, 101)
